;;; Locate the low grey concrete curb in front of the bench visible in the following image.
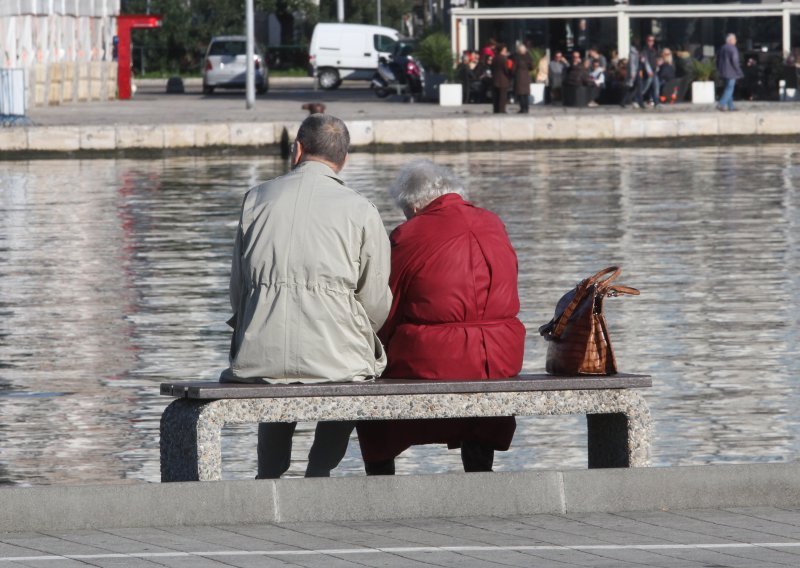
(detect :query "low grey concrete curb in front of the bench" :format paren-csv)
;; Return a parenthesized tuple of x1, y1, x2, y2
(0, 463, 800, 532)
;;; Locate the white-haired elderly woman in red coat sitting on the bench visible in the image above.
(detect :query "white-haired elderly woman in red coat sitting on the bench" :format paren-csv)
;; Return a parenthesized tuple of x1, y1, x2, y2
(358, 160, 525, 475)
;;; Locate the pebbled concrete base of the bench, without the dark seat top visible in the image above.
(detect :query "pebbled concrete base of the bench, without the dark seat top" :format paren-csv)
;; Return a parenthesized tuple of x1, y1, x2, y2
(161, 389, 652, 482)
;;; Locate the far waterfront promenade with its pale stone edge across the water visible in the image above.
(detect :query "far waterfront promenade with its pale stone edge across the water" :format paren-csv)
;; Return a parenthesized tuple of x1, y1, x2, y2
(0, 78, 800, 157)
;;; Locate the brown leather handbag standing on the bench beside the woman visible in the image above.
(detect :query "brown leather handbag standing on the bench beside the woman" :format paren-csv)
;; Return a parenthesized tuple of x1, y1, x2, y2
(539, 266, 639, 376)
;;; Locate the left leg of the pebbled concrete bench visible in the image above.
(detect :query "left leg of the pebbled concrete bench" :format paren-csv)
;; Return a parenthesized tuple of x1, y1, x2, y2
(161, 399, 222, 482)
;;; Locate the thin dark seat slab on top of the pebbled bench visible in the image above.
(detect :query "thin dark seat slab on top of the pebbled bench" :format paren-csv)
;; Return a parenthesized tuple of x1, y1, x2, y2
(161, 373, 653, 400)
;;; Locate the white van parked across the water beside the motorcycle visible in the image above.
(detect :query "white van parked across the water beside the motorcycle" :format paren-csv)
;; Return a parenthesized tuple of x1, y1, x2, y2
(308, 24, 400, 89)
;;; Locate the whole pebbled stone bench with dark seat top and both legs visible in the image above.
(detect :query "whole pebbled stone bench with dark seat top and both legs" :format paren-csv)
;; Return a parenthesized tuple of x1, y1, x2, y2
(161, 374, 652, 482)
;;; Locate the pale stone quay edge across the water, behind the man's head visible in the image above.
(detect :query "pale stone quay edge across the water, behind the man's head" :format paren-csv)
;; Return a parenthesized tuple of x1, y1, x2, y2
(0, 109, 800, 153)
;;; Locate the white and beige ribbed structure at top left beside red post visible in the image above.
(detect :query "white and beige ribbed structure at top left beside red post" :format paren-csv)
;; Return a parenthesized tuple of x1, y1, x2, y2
(0, 0, 120, 107)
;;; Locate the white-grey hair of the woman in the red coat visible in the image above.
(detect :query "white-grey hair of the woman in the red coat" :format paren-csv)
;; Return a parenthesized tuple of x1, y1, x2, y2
(389, 159, 467, 210)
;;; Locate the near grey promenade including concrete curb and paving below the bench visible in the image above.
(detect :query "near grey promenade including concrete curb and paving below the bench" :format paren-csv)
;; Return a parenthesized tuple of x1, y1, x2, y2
(0, 464, 800, 568)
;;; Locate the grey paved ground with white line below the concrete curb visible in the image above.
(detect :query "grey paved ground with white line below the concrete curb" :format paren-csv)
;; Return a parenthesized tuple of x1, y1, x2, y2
(0, 507, 800, 568)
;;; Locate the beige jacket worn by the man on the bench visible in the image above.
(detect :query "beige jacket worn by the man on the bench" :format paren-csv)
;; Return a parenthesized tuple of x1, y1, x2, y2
(220, 161, 392, 382)
